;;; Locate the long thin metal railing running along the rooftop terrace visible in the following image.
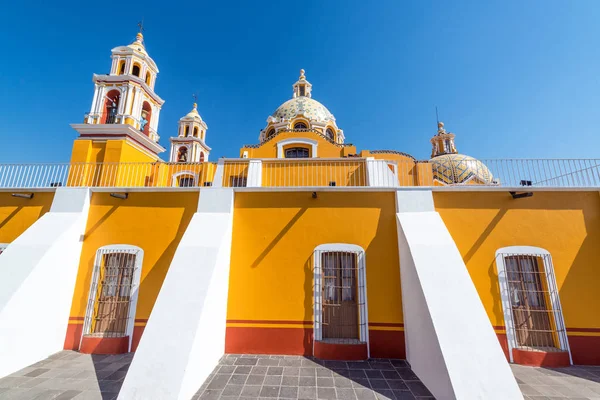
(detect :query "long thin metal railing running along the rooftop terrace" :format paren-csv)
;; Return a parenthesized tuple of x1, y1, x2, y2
(0, 157, 600, 189)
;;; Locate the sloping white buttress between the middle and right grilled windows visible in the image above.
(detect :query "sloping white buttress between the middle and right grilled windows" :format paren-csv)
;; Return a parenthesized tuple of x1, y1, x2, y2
(397, 191, 523, 400)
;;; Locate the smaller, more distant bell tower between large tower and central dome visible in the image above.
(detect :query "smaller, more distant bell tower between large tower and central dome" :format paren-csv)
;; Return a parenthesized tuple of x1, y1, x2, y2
(169, 103, 211, 163)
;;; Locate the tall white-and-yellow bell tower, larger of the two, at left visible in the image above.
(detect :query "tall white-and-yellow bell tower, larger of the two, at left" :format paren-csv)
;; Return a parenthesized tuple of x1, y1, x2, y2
(71, 29, 165, 162)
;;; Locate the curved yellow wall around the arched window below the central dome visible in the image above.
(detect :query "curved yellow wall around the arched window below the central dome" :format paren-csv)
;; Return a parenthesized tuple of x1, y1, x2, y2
(240, 132, 356, 158)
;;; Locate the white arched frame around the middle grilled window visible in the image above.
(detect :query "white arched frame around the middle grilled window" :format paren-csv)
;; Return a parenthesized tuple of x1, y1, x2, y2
(313, 243, 371, 357)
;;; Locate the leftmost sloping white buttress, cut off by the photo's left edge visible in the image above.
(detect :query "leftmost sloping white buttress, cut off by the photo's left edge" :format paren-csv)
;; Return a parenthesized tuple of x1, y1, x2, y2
(0, 188, 90, 377)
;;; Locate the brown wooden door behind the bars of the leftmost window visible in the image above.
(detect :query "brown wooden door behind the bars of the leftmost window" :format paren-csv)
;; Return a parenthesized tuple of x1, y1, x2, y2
(92, 253, 135, 336)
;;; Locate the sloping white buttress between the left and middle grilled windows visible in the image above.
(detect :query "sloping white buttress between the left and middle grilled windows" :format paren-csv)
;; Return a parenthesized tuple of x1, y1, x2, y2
(119, 188, 233, 400)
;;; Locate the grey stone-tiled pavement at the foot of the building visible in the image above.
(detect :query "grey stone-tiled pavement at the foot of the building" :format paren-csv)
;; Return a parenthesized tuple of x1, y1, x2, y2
(0, 351, 600, 400)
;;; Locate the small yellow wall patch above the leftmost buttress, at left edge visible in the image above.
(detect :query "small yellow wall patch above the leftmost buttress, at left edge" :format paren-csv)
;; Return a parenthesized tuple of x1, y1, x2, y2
(0, 192, 54, 243)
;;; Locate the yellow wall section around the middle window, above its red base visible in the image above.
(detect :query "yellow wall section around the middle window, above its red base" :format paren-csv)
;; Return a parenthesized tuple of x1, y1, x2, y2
(227, 192, 402, 323)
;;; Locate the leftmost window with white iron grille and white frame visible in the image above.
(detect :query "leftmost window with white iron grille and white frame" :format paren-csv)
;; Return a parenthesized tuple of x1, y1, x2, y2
(84, 245, 143, 338)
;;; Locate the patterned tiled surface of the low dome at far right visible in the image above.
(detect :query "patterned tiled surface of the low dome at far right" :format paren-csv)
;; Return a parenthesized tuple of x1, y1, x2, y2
(429, 154, 493, 185)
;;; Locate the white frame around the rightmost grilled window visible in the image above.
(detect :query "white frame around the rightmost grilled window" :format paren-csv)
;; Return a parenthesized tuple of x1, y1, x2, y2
(496, 246, 573, 364)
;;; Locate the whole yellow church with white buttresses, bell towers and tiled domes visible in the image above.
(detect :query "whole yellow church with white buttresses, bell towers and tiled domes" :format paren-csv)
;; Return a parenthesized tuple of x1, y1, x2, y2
(0, 33, 600, 400)
